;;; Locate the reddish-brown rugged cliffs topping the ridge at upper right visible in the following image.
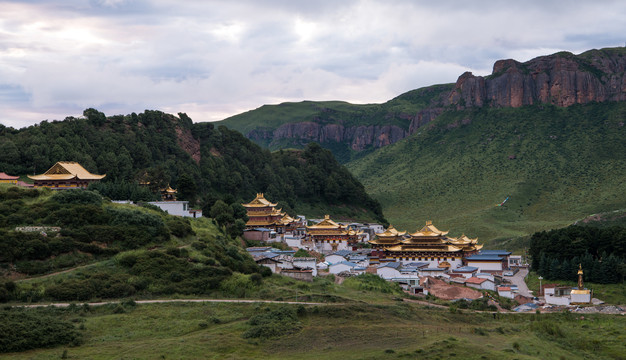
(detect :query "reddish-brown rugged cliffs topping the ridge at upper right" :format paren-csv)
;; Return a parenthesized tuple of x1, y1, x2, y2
(443, 49, 626, 109)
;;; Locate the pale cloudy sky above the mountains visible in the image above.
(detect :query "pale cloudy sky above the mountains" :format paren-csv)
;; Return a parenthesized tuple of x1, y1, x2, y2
(0, 0, 626, 128)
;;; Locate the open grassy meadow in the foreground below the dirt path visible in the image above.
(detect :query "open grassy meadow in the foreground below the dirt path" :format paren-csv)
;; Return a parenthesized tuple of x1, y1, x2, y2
(3, 303, 626, 359)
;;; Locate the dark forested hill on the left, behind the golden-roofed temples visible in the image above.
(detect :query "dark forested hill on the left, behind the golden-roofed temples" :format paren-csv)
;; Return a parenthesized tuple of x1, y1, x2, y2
(0, 109, 385, 223)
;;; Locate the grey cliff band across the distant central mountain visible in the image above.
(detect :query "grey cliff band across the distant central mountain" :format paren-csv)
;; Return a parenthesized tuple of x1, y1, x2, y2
(246, 121, 408, 151)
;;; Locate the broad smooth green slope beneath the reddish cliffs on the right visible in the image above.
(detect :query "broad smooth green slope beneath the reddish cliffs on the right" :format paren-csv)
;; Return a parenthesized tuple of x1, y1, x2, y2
(347, 102, 626, 240)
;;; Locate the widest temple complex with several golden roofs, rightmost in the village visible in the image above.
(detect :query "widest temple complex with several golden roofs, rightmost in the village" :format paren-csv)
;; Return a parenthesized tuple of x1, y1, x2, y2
(370, 221, 482, 269)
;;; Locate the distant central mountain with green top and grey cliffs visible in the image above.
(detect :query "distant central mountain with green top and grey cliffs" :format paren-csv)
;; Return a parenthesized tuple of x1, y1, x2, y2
(218, 84, 453, 162)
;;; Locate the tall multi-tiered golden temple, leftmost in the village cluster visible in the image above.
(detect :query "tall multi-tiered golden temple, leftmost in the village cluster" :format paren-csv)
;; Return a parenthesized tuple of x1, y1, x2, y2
(241, 193, 299, 234)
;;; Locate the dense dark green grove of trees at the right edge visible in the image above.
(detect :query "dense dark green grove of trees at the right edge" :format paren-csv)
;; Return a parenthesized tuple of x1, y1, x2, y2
(528, 225, 626, 284)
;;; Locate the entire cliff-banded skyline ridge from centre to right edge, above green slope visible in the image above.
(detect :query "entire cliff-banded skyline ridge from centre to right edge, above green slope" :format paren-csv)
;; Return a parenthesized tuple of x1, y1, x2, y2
(216, 48, 626, 163)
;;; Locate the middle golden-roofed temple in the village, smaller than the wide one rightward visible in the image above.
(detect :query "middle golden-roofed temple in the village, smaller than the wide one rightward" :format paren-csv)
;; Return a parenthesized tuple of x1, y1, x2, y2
(306, 215, 363, 254)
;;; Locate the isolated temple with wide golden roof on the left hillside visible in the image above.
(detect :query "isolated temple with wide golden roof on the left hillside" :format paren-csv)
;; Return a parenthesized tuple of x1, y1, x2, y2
(28, 161, 106, 190)
